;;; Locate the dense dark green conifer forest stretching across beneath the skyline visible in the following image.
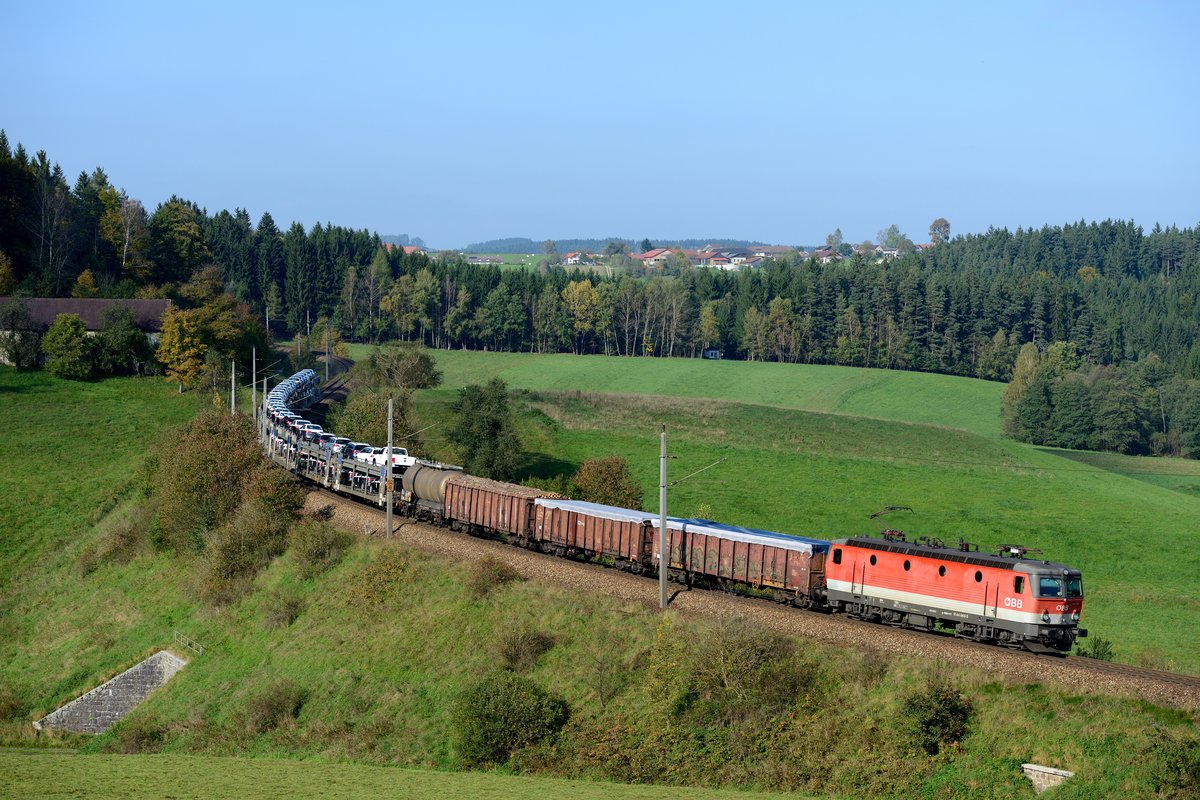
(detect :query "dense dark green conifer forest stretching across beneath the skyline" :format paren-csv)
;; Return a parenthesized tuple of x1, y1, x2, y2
(0, 132, 1200, 456)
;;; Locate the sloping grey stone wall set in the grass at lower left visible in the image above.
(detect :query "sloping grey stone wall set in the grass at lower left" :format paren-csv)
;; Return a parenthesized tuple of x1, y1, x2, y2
(34, 650, 187, 733)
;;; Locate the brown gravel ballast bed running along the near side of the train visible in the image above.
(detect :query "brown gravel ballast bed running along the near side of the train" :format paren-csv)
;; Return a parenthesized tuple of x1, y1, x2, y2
(305, 491, 1200, 710)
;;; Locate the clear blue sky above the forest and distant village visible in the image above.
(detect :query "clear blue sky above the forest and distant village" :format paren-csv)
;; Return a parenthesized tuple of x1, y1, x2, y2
(0, 0, 1200, 247)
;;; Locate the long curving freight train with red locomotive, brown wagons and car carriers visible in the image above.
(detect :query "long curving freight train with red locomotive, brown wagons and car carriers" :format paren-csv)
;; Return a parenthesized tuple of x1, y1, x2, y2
(259, 369, 1087, 654)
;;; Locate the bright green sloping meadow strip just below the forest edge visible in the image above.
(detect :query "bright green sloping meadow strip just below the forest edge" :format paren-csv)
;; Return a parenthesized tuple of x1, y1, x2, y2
(350, 344, 1004, 437)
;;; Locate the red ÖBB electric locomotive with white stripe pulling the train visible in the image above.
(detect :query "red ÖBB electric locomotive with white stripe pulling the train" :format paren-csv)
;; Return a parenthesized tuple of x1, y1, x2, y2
(826, 531, 1087, 654)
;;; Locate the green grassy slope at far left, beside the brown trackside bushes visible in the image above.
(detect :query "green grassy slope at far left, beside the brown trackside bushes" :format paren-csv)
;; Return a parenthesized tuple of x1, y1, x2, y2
(0, 367, 204, 743)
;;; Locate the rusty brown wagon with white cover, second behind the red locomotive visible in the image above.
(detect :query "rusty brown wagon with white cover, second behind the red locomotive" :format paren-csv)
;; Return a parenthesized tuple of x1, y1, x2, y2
(533, 498, 652, 571)
